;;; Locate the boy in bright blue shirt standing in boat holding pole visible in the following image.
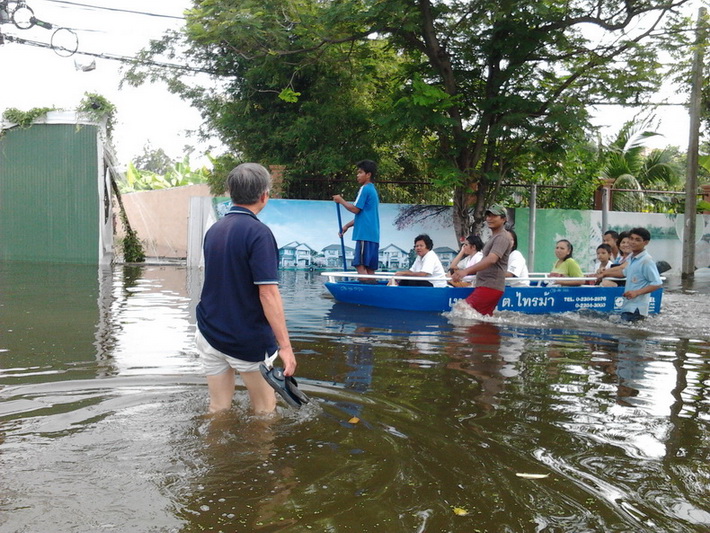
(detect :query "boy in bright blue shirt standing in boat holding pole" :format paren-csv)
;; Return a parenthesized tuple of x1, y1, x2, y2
(333, 159, 380, 274)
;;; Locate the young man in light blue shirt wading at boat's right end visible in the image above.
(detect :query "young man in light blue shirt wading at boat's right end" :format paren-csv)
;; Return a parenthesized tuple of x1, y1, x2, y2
(598, 228, 663, 322)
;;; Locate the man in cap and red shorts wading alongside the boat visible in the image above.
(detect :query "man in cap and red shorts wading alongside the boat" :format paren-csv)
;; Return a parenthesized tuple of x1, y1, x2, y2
(451, 205, 513, 315)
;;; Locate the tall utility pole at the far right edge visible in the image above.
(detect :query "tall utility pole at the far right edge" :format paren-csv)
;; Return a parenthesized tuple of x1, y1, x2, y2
(681, 7, 707, 279)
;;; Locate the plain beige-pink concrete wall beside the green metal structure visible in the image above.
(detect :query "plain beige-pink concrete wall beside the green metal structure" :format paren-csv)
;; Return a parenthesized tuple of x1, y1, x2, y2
(116, 184, 212, 259)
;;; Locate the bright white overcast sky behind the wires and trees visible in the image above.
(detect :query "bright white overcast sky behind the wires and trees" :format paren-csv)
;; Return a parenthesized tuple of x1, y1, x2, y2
(0, 0, 700, 170)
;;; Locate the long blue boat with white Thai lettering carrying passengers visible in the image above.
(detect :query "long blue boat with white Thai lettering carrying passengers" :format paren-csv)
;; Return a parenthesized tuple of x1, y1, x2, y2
(323, 272, 663, 315)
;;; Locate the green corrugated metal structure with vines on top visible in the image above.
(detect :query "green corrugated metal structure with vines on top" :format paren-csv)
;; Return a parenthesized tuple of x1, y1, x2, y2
(0, 111, 115, 264)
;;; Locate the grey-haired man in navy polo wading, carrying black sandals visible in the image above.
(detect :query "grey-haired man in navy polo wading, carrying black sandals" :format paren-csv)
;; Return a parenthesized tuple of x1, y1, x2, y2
(195, 163, 296, 414)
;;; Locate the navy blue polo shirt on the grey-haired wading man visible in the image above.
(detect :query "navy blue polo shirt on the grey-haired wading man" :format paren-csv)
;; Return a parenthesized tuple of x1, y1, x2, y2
(197, 206, 279, 362)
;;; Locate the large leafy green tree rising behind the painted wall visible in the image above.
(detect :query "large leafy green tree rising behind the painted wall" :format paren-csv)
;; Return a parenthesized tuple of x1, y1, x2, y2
(128, 0, 688, 235)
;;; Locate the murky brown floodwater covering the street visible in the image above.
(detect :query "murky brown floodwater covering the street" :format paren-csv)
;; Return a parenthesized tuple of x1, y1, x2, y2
(0, 263, 710, 533)
